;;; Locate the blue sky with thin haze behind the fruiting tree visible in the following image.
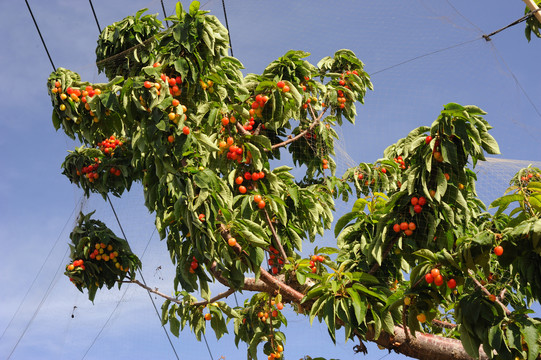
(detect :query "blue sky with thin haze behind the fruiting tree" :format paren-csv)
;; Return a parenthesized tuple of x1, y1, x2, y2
(0, 0, 541, 359)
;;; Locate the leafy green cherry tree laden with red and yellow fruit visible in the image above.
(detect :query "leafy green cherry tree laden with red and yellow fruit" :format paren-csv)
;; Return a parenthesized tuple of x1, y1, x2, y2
(48, 1, 541, 360)
